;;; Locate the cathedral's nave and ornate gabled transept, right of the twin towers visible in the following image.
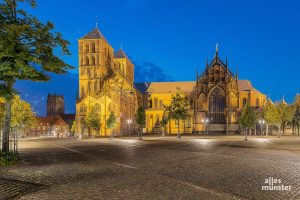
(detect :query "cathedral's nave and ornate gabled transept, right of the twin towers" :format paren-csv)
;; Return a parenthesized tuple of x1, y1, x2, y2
(135, 49, 266, 134)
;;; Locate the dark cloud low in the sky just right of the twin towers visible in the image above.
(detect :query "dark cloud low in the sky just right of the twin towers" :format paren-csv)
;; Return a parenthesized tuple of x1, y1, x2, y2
(134, 61, 174, 82)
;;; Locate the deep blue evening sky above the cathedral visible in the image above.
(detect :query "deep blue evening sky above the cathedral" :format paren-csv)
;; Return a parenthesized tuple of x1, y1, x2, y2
(17, 0, 300, 115)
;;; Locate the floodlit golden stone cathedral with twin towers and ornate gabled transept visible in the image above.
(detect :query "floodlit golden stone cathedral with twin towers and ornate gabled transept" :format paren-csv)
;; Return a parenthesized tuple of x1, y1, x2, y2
(76, 27, 266, 136)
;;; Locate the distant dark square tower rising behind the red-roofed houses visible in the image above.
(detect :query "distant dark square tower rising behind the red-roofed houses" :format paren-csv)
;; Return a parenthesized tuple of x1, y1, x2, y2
(47, 94, 65, 117)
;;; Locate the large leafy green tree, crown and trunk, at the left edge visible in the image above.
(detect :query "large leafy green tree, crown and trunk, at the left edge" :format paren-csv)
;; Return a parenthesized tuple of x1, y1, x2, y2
(0, 0, 72, 152)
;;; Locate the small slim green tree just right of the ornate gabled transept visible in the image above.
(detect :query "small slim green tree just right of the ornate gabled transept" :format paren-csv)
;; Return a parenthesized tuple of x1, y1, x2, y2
(239, 103, 256, 141)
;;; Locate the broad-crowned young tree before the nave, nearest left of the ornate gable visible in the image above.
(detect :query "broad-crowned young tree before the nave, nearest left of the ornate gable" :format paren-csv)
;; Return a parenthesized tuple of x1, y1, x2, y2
(165, 88, 189, 138)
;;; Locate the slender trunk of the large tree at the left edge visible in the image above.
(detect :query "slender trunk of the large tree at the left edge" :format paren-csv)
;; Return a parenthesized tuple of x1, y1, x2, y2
(2, 98, 12, 153)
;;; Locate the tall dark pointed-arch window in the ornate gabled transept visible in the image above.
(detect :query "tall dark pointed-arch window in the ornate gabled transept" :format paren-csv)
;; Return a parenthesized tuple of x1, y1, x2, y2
(209, 87, 226, 124)
